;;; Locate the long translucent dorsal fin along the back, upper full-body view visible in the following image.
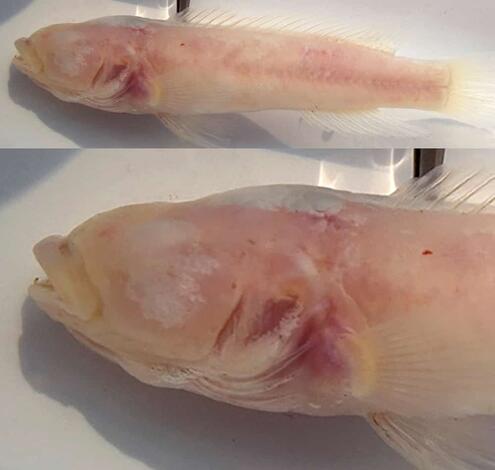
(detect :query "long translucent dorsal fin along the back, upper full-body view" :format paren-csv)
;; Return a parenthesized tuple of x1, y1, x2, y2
(177, 9, 396, 53)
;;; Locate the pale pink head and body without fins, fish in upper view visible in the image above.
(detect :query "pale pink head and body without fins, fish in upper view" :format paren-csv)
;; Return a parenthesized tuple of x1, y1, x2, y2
(14, 12, 480, 140)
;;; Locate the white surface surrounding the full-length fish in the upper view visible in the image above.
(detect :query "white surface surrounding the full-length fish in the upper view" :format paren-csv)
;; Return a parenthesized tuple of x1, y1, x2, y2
(0, 0, 495, 148)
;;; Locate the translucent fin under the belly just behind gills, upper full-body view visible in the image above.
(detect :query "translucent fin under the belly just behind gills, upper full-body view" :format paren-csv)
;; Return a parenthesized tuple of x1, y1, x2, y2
(158, 114, 234, 148)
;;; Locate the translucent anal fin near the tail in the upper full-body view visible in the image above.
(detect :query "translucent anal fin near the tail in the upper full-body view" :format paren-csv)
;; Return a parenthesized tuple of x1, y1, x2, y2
(303, 109, 425, 137)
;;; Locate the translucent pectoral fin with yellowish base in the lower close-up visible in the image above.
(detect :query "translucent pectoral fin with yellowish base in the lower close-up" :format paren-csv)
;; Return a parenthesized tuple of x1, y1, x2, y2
(344, 311, 495, 417)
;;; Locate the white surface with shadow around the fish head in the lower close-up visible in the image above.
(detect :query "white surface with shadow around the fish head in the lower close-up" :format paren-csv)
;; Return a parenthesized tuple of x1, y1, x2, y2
(0, 150, 412, 470)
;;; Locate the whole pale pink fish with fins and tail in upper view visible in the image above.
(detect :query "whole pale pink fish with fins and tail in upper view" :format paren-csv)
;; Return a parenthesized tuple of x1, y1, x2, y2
(13, 10, 495, 147)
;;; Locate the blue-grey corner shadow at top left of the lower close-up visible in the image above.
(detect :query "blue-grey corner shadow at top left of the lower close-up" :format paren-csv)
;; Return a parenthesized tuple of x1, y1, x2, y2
(0, 149, 78, 206)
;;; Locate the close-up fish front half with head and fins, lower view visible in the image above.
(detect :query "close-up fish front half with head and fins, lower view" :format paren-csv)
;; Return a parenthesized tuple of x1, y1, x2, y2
(29, 168, 495, 470)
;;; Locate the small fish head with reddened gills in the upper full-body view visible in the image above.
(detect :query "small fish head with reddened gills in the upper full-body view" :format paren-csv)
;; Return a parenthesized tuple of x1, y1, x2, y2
(13, 21, 153, 112)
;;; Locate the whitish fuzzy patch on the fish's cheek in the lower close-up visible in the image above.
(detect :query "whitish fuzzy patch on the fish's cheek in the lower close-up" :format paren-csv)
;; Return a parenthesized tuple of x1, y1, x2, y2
(126, 219, 219, 328)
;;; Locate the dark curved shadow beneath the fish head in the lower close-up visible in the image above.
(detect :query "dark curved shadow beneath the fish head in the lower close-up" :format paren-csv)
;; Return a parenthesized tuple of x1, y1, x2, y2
(19, 300, 410, 470)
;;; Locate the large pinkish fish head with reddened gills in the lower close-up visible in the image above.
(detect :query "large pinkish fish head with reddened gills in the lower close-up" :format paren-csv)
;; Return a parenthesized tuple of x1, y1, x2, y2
(30, 195, 356, 406)
